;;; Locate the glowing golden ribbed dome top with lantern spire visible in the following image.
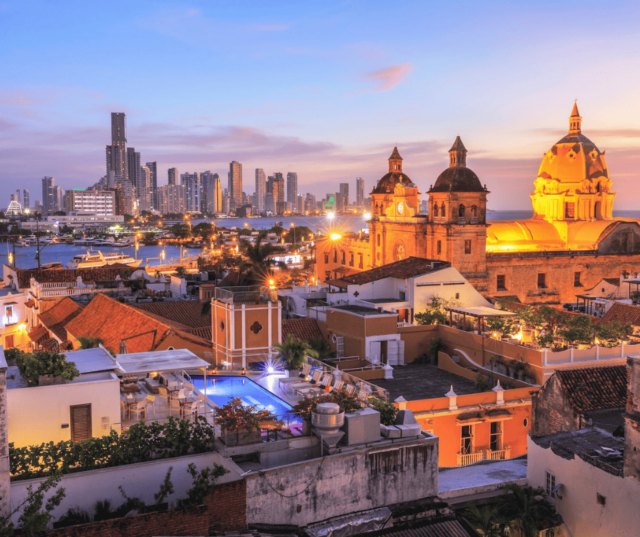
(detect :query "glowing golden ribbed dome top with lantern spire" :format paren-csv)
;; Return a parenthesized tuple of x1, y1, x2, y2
(538, 104, 609, 187)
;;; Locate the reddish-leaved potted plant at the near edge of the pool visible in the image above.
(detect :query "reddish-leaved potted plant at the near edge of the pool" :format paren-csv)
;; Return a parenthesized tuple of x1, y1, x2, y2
(218, 397, 274, 447)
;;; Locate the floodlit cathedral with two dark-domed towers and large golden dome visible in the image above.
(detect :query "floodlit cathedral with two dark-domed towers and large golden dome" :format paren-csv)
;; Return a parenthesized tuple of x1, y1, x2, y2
(316, 104, 640, 305)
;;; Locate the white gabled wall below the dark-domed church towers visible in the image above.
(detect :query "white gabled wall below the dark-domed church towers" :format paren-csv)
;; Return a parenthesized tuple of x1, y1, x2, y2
(407, 267, 492, 314)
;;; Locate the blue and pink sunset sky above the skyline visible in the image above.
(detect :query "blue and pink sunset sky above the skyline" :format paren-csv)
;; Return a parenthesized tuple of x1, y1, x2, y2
(0, 0, 640, 210)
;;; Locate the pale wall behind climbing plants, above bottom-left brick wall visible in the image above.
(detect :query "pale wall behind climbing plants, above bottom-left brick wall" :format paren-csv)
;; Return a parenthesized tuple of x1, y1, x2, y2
(11, 453, 241, 522)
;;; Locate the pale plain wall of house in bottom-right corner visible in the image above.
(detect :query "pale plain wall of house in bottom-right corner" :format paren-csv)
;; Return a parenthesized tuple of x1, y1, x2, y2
(527, 438, 640, 537)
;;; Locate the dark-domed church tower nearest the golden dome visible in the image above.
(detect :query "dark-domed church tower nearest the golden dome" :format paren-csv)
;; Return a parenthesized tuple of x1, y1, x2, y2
(426, 136, 489, 278)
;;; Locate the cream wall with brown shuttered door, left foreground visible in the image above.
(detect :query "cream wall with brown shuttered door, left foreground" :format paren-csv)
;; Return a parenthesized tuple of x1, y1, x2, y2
(7, 373, 121, 447)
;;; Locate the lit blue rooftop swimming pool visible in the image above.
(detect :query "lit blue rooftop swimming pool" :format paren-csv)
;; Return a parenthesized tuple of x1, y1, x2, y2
(192, 376, 293, 417)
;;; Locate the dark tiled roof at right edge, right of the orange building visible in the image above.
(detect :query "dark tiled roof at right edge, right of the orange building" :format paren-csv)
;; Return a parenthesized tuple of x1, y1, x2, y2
(555, 365, 627, 412)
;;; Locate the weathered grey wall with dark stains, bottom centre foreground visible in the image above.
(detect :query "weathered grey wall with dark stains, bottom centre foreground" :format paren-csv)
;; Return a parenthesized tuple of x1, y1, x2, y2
(245, 436, 438, 526)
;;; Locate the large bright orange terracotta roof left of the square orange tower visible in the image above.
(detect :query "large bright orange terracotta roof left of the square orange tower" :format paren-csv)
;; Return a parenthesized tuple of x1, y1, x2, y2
(66, 293, 171, 352)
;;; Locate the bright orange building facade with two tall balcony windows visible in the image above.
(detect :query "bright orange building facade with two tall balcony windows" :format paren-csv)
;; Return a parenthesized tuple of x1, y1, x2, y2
(396, 385, 538, 467)
